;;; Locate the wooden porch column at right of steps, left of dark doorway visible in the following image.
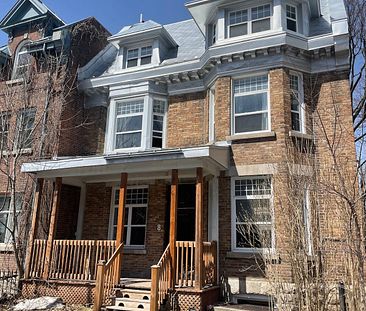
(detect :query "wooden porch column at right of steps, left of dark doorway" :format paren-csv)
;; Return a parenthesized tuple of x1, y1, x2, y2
(169, 170, 179, 288)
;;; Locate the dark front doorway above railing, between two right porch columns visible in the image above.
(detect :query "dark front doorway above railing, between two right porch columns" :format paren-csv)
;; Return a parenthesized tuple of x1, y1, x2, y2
(177, 184, 196, 241)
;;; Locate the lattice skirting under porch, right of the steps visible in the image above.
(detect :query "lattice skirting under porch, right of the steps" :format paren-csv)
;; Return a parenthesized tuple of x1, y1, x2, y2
(177, 286, 220, 311)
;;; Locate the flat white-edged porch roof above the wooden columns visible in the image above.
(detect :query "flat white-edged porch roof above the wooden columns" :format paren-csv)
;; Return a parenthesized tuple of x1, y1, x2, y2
(22, 145, 229, 178)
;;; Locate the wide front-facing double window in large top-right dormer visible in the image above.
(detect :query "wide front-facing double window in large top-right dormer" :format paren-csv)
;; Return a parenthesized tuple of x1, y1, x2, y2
(228, 4, 271, 38)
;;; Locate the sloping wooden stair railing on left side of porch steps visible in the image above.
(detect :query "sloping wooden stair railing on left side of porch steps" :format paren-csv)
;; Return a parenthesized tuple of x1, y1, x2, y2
(93, 244, 123, 311)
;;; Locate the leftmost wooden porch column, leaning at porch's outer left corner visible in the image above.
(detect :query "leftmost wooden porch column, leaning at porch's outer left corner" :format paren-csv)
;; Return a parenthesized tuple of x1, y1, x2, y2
(24, 178, 44, 279)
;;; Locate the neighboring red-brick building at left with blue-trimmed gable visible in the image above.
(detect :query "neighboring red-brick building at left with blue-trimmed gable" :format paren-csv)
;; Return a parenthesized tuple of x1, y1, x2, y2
(0, 0, 110, 271)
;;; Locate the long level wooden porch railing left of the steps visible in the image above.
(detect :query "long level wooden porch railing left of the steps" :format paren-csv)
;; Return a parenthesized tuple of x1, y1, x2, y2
(30, 240, 116, 281)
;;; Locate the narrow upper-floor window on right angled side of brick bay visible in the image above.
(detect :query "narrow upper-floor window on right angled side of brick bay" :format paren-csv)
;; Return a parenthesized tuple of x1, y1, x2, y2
(290, 72, 305, 132)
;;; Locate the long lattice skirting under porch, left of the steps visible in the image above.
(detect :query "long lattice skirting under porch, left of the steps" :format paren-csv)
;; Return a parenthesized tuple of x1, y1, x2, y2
(22, 280, 95, 305)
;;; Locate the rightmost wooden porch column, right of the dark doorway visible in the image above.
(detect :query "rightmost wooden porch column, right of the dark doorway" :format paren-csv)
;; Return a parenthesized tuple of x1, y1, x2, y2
(195, 167, 203, 289)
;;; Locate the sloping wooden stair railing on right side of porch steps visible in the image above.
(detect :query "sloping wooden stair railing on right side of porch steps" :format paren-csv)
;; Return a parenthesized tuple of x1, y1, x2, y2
(150, 245, 172, 311)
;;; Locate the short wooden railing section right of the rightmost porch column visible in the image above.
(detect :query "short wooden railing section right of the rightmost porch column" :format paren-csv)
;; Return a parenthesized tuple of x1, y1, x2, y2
(202, 241, 217, 287)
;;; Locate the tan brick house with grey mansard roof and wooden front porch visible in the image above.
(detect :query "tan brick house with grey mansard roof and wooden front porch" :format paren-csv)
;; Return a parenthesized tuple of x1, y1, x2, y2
(2, 0, 356, 311)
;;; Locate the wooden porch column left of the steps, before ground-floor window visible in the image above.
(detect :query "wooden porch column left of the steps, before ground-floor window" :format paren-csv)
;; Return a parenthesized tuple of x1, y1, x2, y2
(115, 173, 128, 284)
